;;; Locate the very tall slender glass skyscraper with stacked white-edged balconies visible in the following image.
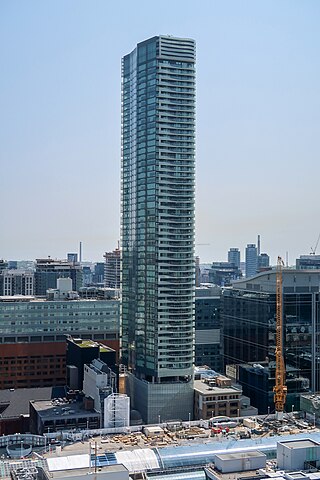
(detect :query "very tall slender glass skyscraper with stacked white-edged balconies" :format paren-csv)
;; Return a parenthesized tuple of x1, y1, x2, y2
(121, 36, 195, 423)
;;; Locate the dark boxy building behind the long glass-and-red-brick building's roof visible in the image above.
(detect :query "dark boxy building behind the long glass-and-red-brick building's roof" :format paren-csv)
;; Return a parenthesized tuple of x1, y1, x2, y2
(34, 257, 82, 296)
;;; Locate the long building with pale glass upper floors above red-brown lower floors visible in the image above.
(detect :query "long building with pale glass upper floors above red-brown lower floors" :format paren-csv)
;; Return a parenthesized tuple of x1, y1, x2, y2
(0, 296, 120, 389)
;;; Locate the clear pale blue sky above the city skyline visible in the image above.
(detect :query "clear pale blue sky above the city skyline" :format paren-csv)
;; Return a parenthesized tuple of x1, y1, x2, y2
(0, 0, 320, 263)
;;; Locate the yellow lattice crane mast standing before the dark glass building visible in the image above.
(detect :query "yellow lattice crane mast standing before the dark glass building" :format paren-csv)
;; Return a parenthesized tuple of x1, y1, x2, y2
(273, 257, 287, 420)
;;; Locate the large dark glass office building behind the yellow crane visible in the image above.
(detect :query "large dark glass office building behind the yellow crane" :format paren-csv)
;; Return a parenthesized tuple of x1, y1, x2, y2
(221, 269, 320, 413)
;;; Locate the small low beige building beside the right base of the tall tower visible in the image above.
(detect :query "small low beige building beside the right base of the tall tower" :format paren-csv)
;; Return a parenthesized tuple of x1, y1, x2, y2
(194, 375, 242, 420)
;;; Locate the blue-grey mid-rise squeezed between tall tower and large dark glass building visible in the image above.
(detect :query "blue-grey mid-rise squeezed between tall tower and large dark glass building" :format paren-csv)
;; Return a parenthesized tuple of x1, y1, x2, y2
(195, 284, 223, 372)
